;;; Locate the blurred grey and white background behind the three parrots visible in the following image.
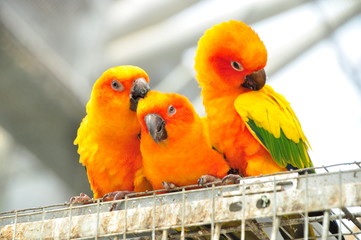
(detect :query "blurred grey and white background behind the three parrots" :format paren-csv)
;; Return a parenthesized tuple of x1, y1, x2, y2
(0, 0, 361, 211)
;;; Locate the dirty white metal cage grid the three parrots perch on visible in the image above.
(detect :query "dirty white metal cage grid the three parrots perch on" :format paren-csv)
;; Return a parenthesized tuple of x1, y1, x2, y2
(0, 162, 361, 240)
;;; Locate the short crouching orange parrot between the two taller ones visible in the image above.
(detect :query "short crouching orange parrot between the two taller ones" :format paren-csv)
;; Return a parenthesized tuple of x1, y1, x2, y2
(137, 91, 229, 189)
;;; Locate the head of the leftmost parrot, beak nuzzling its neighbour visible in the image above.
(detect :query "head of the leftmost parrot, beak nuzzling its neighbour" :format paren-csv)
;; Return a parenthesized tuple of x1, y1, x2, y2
(87, 66, 150, 123)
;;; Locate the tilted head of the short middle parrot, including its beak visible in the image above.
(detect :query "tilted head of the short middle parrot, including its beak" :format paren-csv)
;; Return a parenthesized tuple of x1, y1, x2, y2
(137, 91, 195, 144)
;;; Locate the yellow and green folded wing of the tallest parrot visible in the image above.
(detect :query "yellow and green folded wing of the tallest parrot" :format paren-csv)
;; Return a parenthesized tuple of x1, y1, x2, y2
(234, 86, 313, 168)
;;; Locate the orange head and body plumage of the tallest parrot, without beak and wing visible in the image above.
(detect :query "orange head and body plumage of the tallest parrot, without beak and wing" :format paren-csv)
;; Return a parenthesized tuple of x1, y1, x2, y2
(195, 21, 286, 176)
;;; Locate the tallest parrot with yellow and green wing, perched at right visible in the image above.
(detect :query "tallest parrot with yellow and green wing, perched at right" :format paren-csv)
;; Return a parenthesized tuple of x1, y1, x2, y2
(194, 20, 338, 240)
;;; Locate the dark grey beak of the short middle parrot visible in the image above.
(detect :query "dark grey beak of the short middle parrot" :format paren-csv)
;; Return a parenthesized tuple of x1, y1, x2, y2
(144, 113, 168, 143)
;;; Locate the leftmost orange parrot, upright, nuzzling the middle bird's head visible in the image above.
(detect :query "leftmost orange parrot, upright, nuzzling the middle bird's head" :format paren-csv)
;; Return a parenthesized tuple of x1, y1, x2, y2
(71, 66, 150, 203)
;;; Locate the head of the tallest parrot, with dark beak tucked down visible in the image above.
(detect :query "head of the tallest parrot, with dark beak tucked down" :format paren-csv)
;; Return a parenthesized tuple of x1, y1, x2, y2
(195, 20, 267, 91)
